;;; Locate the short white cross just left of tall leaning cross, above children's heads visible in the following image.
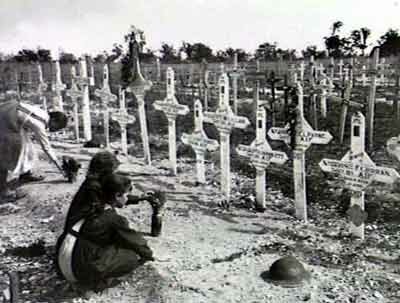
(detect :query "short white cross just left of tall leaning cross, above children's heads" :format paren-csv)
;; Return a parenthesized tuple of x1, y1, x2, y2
(111, 87, 136, 156)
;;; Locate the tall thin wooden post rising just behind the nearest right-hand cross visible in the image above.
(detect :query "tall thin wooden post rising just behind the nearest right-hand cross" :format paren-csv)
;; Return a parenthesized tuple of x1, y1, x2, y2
(367, 47, 379, 150)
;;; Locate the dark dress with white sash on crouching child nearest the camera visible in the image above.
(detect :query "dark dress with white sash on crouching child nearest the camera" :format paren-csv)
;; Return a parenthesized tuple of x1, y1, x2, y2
(57, 179, 153, 284)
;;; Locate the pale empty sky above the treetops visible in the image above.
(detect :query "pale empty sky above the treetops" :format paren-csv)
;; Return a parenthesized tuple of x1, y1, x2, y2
(0, 0, 400, 55)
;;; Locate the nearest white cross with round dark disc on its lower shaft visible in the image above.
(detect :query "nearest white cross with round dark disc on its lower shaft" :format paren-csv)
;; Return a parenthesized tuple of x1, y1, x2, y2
(319, 112, 400, 239)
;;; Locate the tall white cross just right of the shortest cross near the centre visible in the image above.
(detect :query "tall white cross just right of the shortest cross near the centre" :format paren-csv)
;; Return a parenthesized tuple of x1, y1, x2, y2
(204, 74, 250, 202)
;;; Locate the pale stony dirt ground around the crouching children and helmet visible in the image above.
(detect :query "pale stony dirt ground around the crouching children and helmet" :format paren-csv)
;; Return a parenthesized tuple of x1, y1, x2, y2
(0, 138, 400, 303)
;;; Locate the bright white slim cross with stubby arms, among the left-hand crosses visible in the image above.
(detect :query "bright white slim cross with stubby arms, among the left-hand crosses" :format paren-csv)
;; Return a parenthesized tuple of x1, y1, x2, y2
(76, 58, 94, 141)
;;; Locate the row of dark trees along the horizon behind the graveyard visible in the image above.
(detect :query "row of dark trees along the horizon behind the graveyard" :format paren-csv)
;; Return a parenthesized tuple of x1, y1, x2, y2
(0, 21, 400, 64)
